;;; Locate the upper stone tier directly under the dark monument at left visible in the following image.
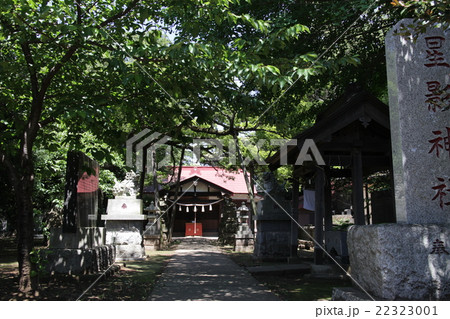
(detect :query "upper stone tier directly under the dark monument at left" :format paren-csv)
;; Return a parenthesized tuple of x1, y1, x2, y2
(49, 227, 105, 249)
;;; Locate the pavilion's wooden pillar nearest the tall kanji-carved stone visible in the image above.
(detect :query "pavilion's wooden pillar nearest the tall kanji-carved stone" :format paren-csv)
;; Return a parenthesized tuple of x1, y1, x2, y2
(352, 149, 365, 225)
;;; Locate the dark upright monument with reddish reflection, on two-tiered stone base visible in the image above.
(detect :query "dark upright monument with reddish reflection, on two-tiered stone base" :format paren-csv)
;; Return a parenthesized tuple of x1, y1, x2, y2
(47, 151, 115, 274)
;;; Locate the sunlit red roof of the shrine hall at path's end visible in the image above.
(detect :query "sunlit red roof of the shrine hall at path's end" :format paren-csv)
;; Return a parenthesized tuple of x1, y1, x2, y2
(175, 166, 248, 194)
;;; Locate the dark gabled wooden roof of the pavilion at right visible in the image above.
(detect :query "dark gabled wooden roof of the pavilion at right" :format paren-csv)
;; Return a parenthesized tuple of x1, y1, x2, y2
(267, 86, 391, 175)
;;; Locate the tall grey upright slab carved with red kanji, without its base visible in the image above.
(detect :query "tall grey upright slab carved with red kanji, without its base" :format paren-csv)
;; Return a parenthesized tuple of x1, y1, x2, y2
(386, 20, 450, 224)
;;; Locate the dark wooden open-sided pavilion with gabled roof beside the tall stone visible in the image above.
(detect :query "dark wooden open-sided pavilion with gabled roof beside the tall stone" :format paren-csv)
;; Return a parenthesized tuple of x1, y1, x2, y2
(267, 85, 395, 264)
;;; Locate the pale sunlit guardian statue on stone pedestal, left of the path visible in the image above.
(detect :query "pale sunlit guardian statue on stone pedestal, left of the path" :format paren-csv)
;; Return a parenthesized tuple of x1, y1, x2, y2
(101, 172, 147, 260)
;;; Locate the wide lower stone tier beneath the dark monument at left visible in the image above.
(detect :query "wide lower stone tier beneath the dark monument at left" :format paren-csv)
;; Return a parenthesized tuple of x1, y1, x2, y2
(45, 245, 116, 274)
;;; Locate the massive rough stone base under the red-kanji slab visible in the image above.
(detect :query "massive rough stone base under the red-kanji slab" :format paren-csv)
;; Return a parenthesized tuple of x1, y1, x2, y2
(347, 224, 450, 300)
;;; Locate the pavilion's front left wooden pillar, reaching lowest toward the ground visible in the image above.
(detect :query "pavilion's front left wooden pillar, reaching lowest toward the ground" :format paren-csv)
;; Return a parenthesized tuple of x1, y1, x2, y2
(314, 167, 325, 265)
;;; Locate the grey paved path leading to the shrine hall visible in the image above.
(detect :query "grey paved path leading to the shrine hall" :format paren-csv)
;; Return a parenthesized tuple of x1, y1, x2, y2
(149, 238, 280, 301)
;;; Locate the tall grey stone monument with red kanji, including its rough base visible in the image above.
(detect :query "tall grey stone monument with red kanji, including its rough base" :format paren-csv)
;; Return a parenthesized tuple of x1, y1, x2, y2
(342, 19, 450, 300)
